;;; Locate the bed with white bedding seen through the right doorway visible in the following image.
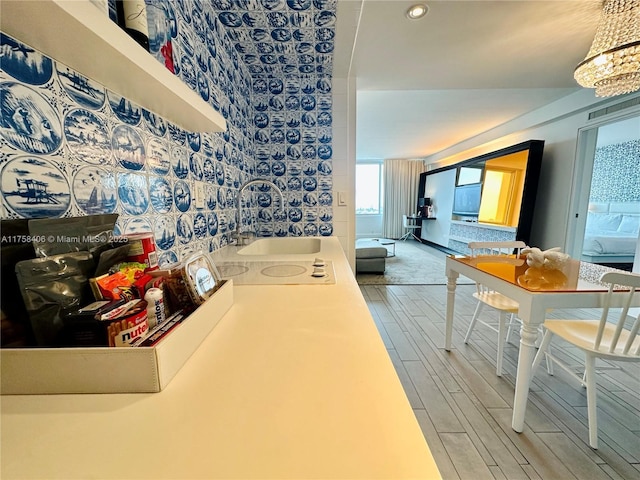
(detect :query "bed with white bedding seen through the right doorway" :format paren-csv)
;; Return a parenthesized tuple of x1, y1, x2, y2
(582, 202, 640, 263)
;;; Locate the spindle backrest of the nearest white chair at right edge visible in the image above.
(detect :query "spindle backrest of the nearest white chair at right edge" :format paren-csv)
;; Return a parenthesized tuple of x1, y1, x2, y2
(594, 272, 640, 355)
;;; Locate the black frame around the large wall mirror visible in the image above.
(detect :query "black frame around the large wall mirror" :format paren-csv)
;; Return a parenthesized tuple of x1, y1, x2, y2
(418, 140, 544, 248)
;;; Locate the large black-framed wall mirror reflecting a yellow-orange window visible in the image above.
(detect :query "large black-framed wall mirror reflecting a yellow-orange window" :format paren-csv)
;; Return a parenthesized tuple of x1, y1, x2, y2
(418, 140, 544, 252)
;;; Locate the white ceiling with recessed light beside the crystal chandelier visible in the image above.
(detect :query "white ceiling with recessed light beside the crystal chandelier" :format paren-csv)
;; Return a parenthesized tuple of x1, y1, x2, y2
(334, 0, 602, 160)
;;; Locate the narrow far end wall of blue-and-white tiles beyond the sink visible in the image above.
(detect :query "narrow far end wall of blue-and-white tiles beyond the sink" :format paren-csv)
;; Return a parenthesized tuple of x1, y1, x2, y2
(218, 0, 337, 236)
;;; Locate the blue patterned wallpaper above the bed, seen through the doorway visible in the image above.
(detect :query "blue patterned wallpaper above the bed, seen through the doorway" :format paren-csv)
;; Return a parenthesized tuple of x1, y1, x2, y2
(589, 141, 640, 202)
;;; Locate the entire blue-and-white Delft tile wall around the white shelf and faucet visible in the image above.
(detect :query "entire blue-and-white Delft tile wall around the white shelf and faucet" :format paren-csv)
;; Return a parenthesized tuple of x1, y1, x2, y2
(0, 0, 337, 264)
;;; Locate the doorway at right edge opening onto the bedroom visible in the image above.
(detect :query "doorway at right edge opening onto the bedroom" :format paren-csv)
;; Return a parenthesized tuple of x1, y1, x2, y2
(567, 110, 640, 272)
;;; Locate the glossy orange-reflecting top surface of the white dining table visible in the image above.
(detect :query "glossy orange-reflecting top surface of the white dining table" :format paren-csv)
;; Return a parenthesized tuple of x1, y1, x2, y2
(447, 255, 632, 293)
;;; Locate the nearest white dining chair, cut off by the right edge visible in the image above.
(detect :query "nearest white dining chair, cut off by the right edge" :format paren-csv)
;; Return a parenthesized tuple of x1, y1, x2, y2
(532, 272, 640, 449)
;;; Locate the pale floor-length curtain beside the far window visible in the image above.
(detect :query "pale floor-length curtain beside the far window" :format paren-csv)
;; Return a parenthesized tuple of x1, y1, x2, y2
(382, 159, 426, 238)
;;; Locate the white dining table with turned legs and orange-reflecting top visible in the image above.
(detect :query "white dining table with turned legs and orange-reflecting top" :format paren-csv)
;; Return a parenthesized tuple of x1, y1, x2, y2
(444, 255, 640, 432)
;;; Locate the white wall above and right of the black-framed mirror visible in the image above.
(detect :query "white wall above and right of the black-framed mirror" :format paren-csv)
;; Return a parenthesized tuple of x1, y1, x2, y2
(425, 90, 640, 249)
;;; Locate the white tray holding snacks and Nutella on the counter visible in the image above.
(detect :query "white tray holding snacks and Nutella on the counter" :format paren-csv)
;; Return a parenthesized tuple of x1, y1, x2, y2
(0, 280, 233, 395)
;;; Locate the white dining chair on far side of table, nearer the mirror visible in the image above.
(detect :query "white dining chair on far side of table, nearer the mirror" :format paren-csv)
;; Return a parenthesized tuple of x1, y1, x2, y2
(464, 240, 526, 377)
